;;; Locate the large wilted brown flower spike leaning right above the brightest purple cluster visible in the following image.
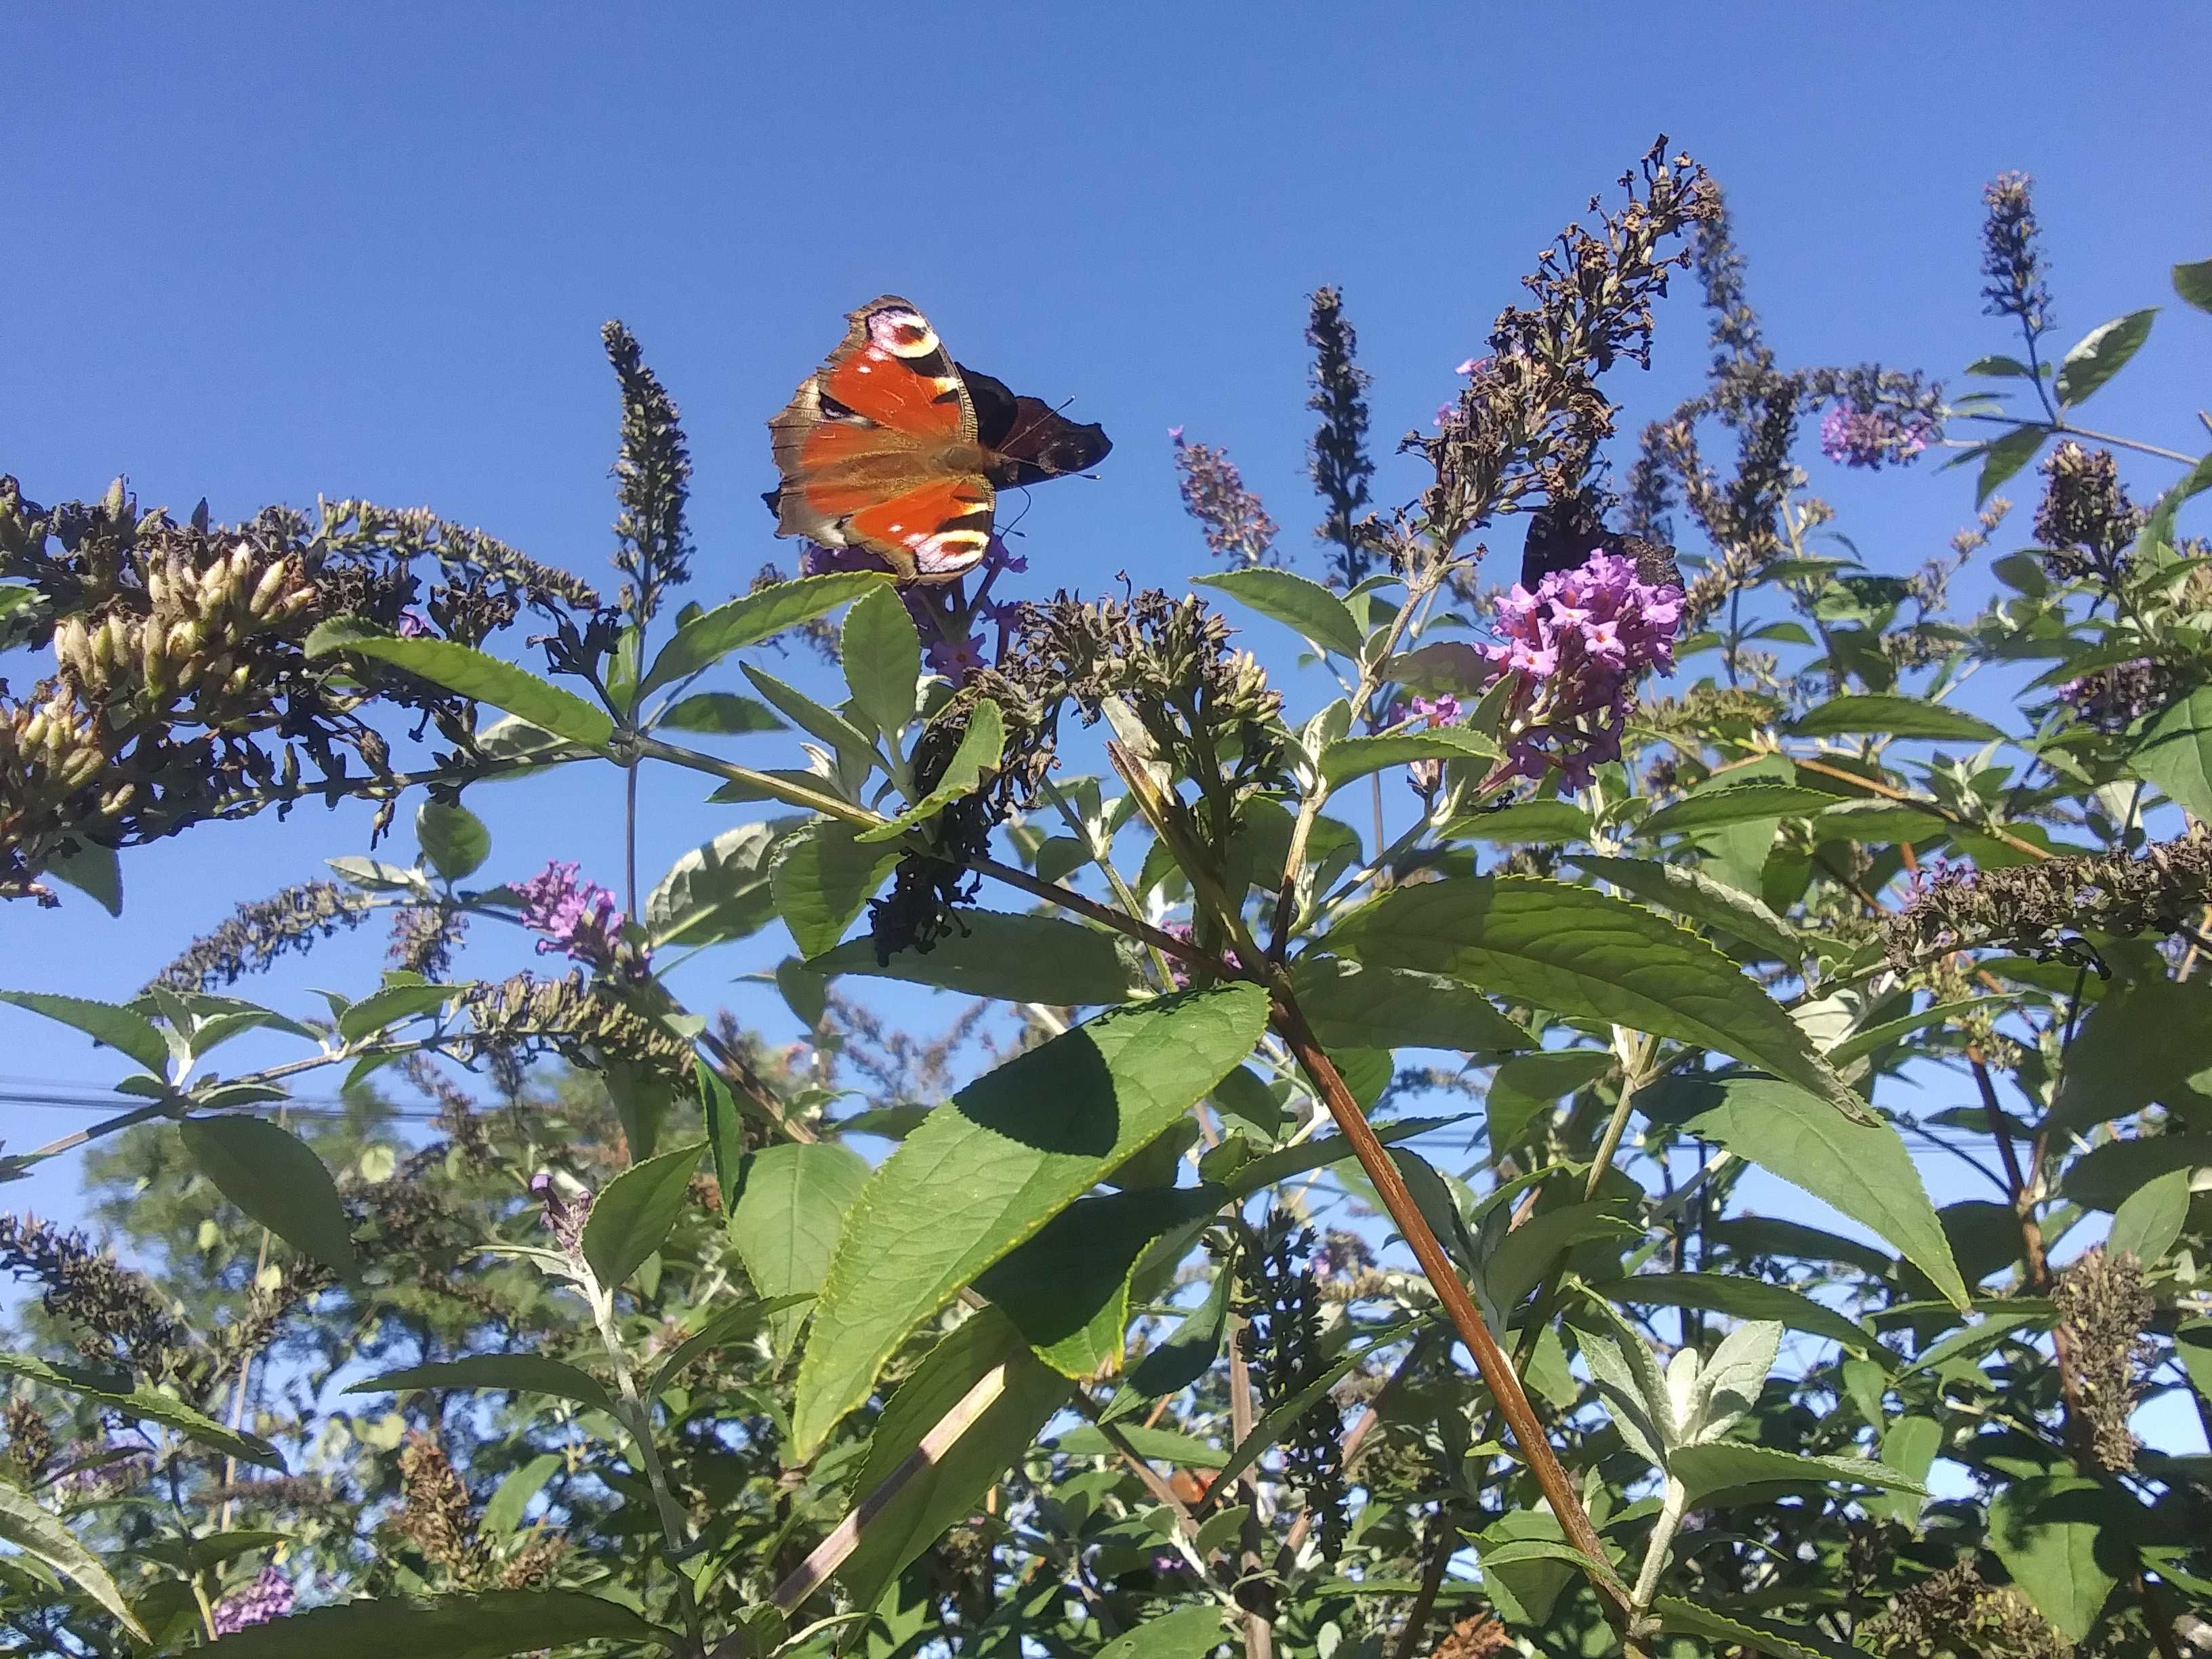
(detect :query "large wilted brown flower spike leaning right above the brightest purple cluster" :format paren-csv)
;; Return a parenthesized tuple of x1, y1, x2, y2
(1405, 137, 1719, 546)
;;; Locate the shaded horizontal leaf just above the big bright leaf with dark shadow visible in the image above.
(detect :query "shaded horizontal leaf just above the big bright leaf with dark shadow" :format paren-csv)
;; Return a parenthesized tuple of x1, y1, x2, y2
(807, 909, 1139, 1008)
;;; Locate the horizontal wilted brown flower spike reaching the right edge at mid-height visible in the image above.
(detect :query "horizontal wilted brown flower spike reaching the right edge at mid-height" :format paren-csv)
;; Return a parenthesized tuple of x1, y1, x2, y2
(1883, 825, 2212, 969)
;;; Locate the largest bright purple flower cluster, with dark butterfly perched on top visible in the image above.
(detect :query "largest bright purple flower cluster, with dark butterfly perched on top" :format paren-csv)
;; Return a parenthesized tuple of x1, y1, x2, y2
(1475, 551, 1681, 790)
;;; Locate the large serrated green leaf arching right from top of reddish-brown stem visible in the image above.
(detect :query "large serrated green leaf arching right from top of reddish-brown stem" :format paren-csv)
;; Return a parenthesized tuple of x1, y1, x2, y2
(1332, 876, 1874, 1124)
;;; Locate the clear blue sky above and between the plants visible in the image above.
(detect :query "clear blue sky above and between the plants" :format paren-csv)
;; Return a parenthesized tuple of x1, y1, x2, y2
(0, 5, 2212, 1442)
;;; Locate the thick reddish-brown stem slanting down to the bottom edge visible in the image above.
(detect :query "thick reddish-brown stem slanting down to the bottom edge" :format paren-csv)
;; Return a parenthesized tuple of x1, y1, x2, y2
(1274, 975, 1628, 1617)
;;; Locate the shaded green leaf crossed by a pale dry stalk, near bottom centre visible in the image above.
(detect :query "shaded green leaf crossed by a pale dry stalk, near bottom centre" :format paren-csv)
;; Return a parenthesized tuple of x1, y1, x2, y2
(838, 1309, 1069, 1608)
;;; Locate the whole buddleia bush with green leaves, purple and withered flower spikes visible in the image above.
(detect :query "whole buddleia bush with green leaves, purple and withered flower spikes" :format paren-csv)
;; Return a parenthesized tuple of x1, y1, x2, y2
(0, 144, 2212, 1659)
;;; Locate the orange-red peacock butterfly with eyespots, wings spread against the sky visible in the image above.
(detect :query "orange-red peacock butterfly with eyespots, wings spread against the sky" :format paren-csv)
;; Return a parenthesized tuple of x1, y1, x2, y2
(765, 294, 1113, 581)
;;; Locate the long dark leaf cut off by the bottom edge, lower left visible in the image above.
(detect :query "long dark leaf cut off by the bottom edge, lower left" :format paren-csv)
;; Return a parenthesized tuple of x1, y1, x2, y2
(208, 1591, 679, 1659)
